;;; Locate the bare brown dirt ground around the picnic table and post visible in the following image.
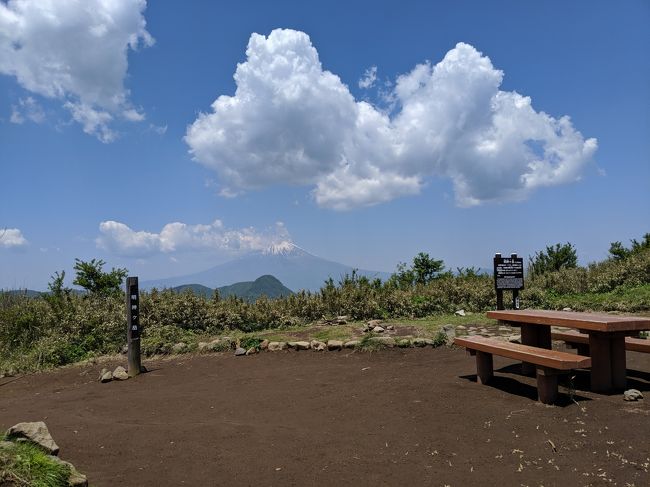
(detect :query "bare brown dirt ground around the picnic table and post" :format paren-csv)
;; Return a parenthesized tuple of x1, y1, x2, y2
(0, 347, 650, 486)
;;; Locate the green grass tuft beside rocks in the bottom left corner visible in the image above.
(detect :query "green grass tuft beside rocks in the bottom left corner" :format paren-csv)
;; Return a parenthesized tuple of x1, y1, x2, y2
(0, 438, 70, 487)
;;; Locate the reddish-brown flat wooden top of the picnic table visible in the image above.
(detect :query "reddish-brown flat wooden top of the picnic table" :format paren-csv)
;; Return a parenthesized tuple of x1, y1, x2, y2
(487, 309, 650, 332)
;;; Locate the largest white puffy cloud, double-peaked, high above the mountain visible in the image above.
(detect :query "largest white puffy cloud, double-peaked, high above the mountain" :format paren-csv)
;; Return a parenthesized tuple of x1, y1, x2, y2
(185, 29, 597, 210)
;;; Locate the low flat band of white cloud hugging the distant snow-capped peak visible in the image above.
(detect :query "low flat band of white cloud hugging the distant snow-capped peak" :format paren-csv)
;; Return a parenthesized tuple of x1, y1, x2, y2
(95, 220, 291, 257)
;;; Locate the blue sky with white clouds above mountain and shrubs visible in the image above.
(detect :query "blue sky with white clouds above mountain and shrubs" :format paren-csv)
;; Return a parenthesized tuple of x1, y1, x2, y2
(0, 0, 650, 289)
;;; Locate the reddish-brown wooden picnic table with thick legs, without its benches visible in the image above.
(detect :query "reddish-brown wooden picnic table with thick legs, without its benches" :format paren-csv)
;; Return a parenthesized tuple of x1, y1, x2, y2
(487, 309, 650, 392)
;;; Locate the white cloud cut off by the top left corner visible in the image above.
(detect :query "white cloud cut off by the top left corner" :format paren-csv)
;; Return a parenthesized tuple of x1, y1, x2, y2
(0, 0, 153, 142)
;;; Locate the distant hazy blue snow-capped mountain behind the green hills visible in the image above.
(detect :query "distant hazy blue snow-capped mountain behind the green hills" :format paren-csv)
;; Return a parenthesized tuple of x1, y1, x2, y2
(140, 242, 390, 291)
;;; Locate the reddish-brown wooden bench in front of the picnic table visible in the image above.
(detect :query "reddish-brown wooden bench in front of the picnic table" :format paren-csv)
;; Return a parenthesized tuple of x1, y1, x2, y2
(454, 336, 591, 404)
